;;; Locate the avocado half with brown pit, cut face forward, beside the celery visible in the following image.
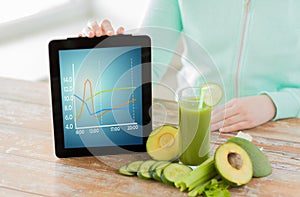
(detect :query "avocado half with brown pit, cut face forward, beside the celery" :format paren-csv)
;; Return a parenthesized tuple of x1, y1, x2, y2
(214, 142, 253, 186)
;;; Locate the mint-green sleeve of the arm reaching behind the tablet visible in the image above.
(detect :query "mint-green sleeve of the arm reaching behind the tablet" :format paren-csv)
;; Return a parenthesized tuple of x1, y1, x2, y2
(141, 0, 182, 84)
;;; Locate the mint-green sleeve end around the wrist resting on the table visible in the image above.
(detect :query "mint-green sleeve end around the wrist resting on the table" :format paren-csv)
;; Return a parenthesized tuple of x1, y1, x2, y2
(263, 88, 300, 120)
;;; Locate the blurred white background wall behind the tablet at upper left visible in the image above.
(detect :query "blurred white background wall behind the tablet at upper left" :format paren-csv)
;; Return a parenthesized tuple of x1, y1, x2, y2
(0, 0, 149, 80)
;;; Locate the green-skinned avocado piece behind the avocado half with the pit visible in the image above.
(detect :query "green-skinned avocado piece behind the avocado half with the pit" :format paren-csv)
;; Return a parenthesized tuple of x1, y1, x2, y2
(228, 137, 272, 178)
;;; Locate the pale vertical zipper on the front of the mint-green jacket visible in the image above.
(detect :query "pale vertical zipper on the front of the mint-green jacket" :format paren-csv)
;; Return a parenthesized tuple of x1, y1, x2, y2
(235, 0, 251, 97)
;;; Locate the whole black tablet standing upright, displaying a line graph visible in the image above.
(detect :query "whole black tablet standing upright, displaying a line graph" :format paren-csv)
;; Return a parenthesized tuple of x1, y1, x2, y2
(49, 35, 152, 157)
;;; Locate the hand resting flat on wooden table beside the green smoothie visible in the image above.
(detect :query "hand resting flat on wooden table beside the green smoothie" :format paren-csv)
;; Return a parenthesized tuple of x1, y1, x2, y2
(211, 95, 276, 132)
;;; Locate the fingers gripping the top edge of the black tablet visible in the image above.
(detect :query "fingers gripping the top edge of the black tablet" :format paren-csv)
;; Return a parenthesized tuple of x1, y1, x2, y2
(79, 19, 124, 38)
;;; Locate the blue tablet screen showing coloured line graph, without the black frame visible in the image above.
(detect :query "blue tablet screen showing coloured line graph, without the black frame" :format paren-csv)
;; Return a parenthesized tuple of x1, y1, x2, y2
(59, 46, 143, 148)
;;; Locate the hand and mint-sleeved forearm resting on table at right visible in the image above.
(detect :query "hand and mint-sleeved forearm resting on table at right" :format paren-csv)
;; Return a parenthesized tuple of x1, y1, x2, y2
(211, 88, 300, 132)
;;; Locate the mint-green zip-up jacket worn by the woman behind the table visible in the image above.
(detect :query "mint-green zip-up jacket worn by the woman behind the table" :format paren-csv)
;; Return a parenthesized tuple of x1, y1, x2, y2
(143, 0, 300, 120)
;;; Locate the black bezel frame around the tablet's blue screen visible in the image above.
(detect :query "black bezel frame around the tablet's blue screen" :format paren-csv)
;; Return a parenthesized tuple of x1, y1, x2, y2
(49, 35, 152, 158)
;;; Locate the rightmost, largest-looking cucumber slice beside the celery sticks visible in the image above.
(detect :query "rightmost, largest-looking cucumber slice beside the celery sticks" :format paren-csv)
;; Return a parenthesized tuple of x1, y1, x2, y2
(161, 163, 192, 186)
